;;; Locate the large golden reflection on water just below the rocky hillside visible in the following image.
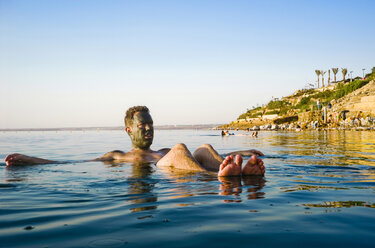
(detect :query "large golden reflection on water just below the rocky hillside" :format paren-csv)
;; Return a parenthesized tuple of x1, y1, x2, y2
(269, 131, 375, 166)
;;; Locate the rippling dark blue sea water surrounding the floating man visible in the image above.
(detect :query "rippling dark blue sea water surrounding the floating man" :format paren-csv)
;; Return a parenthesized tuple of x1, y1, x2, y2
(0, 130, 375, 247)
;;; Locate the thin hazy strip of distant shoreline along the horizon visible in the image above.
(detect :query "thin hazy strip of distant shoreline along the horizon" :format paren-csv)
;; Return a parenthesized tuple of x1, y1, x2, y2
(0, 124, 223, 132)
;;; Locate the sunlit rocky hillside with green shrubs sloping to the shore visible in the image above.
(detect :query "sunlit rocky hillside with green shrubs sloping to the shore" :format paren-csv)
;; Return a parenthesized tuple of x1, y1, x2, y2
(219, 67, 375, 129)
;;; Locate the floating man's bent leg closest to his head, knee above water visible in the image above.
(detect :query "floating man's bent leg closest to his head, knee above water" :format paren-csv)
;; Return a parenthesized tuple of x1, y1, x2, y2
(156, 143, 205, 171)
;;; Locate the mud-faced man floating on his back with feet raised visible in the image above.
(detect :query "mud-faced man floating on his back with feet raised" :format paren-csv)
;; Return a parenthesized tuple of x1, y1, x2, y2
(5, 106, 265, 176)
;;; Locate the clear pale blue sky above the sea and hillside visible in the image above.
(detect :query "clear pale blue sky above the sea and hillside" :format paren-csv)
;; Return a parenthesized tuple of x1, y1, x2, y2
(0, 0, 375, 128)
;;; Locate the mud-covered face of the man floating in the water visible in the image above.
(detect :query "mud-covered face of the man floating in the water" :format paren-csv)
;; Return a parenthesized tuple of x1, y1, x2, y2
(127, 112, 154, 150)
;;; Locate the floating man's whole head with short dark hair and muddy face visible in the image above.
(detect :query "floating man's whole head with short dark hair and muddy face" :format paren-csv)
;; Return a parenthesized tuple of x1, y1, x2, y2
(124, 106, 154, 150)
